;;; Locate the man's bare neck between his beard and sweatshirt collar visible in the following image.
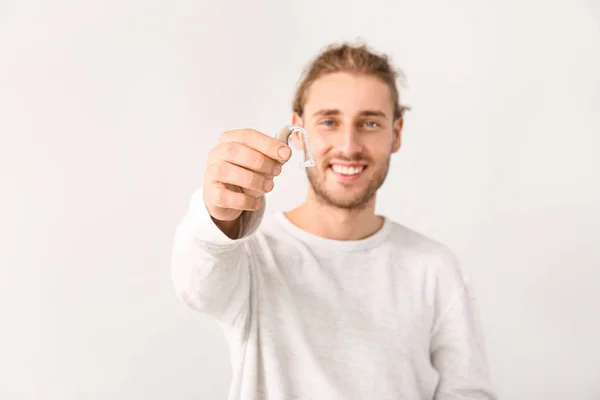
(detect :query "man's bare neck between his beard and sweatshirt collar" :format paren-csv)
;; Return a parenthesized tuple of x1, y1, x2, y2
(285, 191, 383, 240)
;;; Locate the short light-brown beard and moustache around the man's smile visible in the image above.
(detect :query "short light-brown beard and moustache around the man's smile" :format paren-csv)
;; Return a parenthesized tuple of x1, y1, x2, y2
(306, 156, 390, 210)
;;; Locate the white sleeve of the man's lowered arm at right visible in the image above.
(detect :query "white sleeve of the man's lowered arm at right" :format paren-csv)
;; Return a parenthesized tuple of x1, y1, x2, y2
(431, 255, 497, 400)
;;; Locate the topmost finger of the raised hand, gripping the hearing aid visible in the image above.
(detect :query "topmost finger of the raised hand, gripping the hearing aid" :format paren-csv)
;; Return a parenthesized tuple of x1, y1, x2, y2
(219, 129, 292, 162)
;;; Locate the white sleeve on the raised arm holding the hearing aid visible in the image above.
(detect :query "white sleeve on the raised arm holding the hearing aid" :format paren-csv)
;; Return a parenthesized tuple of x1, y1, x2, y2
(171, 188, 265, 324)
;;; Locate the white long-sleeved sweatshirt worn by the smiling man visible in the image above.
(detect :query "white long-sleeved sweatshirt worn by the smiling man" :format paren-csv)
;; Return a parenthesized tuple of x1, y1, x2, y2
(172, 189, 496, 400)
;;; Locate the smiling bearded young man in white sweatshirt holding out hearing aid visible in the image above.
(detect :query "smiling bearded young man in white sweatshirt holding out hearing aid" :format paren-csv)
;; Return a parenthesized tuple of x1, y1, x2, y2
(172, 44, 496, 400)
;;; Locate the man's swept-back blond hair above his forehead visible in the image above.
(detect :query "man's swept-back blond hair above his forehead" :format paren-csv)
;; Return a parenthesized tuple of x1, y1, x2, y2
(292, 43, 409, 119)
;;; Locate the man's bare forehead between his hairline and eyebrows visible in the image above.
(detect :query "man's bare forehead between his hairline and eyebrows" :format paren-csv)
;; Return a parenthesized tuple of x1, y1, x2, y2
(304, 72, 394, 117)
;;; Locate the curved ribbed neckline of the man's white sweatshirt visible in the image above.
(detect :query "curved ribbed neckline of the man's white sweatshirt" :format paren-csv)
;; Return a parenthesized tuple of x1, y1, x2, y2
(274, 211, 393, 251)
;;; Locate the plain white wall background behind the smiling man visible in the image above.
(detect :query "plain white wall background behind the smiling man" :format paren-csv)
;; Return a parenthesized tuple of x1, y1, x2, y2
(0, 0, 600, 400)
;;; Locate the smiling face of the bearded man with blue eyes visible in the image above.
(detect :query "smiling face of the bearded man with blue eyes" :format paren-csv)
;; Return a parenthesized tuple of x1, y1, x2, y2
(294, 72, 402, 209)
